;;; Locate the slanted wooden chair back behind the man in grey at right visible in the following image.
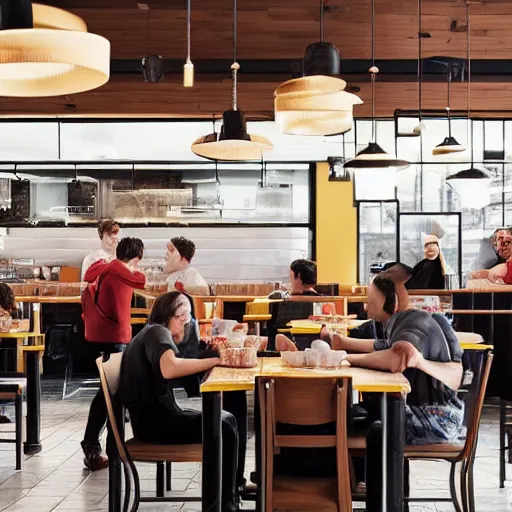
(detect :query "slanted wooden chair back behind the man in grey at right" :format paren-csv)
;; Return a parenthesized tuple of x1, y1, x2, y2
(459, 351, 494, 460)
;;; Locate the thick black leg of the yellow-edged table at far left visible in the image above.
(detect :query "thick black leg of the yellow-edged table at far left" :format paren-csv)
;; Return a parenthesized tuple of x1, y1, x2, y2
(23, 351, 42, 455)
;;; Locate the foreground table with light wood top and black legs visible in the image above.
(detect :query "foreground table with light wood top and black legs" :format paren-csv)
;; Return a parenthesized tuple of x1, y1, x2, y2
(201, 358, 411, 512)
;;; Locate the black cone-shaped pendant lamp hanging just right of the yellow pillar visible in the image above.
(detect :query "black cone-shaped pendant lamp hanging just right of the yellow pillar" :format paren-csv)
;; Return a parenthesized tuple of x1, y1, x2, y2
(344, 0, 409, 169)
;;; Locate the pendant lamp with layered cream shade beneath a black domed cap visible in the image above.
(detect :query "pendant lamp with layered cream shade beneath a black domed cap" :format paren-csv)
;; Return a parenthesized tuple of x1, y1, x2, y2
(274, 0, 362, 136)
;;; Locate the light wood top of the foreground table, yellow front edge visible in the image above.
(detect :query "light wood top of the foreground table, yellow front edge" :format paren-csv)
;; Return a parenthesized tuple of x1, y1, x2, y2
(201, 357, 411, 394)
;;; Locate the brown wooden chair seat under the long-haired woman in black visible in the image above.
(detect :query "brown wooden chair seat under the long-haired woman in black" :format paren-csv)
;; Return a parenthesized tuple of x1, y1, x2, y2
(126, 438, 203, 462)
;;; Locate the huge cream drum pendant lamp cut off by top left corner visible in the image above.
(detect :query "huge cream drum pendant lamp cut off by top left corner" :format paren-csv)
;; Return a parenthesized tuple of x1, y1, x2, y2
(0, 0, 110, 97)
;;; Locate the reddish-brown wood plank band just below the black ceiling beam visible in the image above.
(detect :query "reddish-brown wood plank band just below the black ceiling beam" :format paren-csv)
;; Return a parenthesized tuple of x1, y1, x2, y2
(0, 75, 512, 119)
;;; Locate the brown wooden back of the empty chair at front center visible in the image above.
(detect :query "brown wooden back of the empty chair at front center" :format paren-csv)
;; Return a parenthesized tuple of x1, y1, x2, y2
(257, 377, 352, 512)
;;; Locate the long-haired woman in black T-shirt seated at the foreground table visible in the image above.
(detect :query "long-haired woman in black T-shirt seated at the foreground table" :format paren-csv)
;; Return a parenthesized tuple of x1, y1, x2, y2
(118, 291, 238, 512)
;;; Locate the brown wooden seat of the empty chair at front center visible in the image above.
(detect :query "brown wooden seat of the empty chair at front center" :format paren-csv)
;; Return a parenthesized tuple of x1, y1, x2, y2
(273, 475, 339, 512)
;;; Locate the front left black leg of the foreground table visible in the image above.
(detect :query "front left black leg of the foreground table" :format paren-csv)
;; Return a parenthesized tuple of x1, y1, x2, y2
(201, 392, 222, 512)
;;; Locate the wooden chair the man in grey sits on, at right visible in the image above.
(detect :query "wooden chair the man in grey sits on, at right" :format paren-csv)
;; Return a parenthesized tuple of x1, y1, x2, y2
(349, 351, 494, 512)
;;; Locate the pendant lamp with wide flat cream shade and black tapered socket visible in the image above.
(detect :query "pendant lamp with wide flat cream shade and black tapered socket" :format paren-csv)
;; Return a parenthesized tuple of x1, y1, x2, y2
(191, 0, 274, 162)
